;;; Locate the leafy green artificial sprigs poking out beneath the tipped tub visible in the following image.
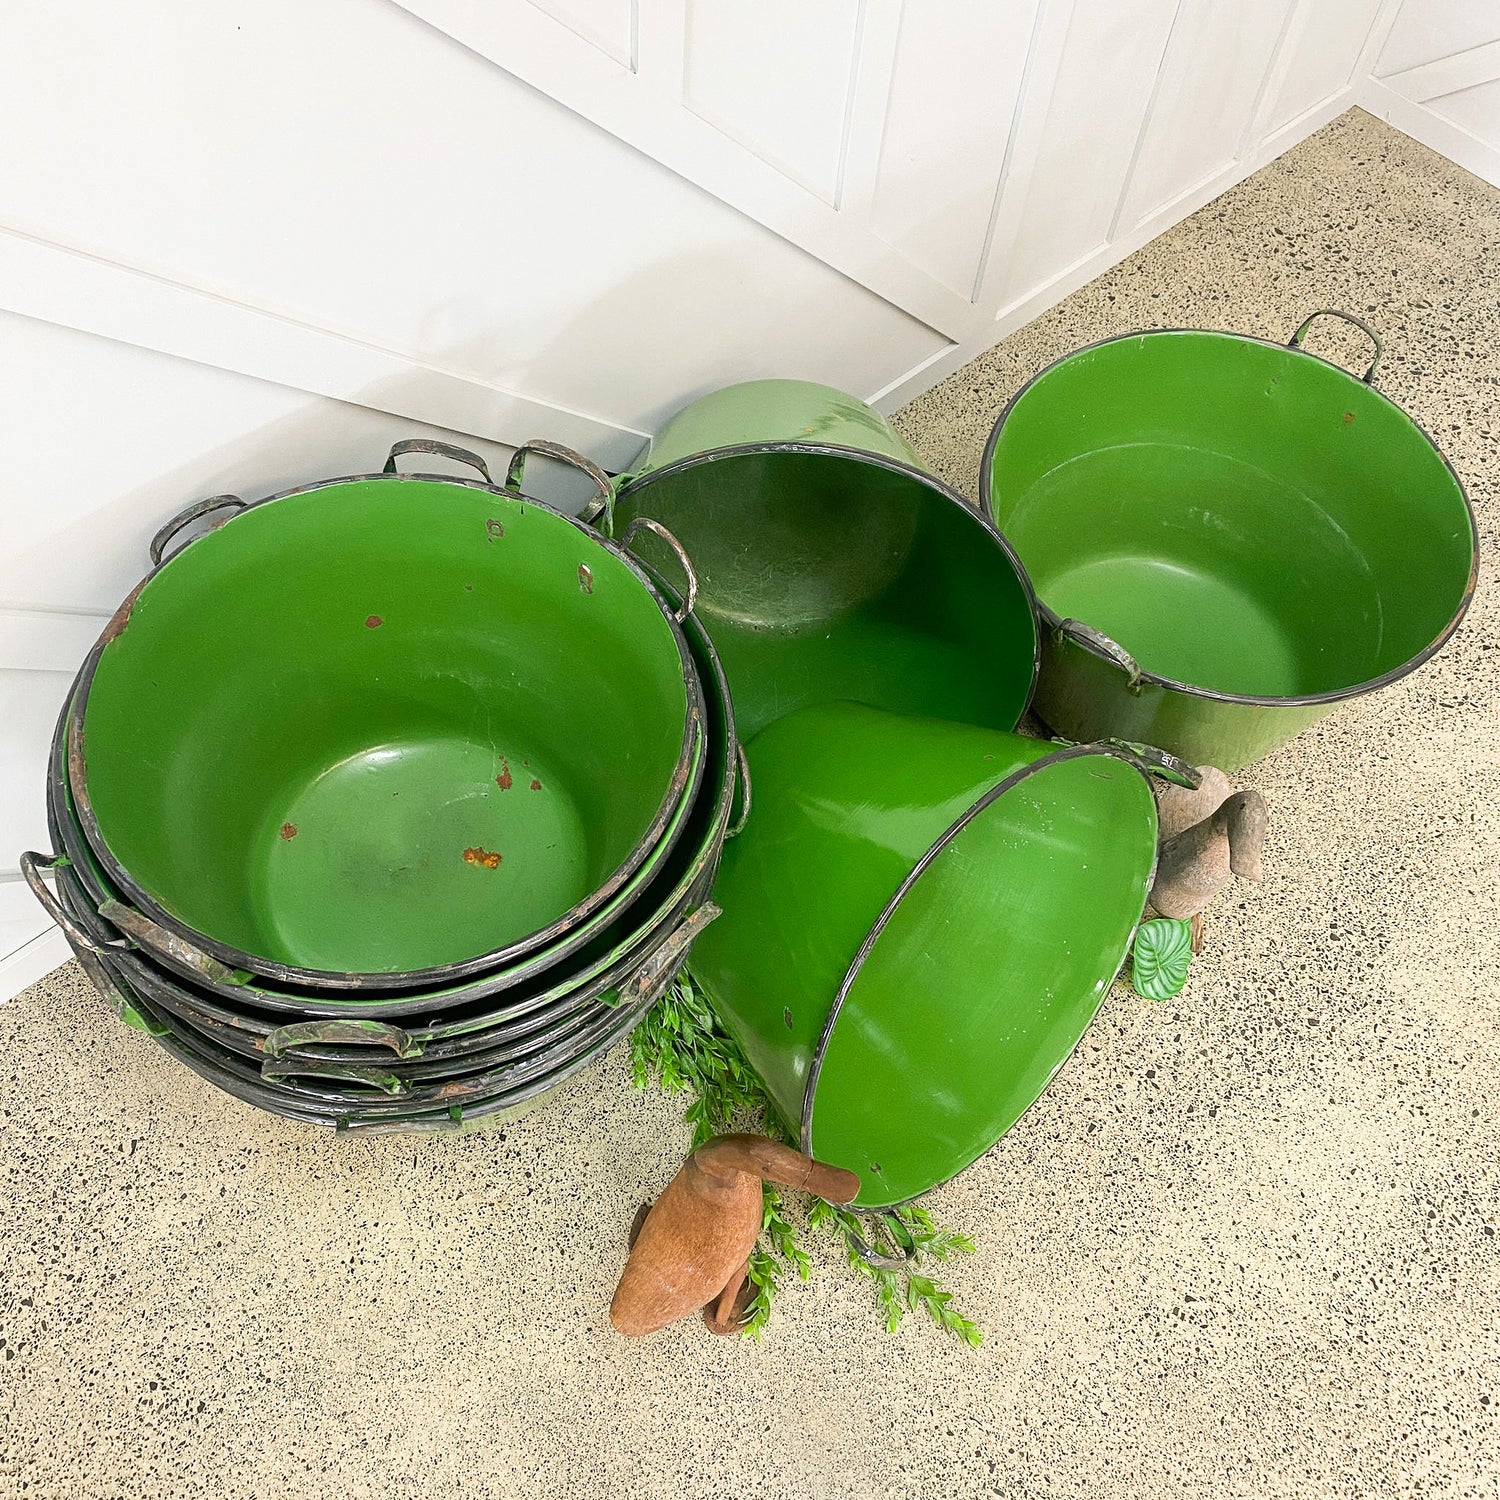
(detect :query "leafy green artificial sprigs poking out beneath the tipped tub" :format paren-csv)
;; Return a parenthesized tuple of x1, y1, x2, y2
(630, 974, 984, 1347)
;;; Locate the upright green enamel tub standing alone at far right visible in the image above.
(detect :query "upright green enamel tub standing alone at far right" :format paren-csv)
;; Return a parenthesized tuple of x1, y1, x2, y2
(981, 309, 1479, 771)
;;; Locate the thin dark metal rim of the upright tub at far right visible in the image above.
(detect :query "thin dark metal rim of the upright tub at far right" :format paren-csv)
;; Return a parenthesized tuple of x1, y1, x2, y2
(980, 329, 1479, 708)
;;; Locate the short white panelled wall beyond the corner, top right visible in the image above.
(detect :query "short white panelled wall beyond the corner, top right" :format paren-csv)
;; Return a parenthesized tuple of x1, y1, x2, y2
(1359, 0, 1500, 186)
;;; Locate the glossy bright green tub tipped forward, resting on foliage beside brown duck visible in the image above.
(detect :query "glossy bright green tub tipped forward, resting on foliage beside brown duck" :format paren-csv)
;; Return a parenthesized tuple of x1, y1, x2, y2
(690, 704, 1157, 1208)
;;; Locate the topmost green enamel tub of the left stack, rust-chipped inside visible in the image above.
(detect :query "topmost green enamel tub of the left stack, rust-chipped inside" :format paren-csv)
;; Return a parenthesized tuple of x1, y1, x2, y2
(68, 443, 707, 992)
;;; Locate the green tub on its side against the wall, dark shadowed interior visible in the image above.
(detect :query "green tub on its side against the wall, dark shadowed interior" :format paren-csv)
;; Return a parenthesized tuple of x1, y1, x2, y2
(614, 381, 1038, 738)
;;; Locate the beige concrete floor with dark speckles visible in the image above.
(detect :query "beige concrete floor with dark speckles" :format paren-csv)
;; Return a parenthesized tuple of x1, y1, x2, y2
(0, 114, 1500, 1500)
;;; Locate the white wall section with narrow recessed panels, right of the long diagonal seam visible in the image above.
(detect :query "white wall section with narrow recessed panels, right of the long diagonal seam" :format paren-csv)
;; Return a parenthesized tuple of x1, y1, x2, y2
(401, 0, 1380, 405)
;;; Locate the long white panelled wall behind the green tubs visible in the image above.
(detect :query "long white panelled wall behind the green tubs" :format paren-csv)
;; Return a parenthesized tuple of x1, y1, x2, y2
(0, 0, 1452, 995)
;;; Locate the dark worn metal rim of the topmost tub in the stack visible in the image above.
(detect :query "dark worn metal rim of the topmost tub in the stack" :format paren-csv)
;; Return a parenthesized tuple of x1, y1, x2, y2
(68, 474, 707, 990)
